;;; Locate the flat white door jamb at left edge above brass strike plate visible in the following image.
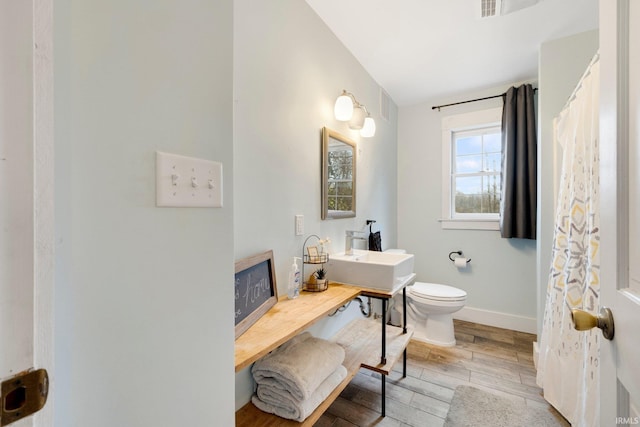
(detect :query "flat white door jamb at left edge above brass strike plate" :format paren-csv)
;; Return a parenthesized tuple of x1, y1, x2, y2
(0, 2, 34, 425)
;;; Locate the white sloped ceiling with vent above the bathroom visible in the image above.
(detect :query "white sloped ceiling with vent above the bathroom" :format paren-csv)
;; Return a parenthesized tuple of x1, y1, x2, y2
(306, 0, 598, 106)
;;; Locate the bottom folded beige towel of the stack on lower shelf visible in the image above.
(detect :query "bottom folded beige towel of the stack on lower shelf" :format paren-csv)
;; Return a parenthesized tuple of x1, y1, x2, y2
(251, 365, 347, 422)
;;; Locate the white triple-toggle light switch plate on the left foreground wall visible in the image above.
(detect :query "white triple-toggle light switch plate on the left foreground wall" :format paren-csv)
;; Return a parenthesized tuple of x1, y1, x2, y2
(156, 151, 222, 208)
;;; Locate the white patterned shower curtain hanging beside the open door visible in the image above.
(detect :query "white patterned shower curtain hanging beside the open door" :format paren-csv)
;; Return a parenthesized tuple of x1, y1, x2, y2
(537, 55, 601, 427)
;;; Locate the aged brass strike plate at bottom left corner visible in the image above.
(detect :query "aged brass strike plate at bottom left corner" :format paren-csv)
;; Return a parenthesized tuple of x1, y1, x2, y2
(0, 369, 49, 427)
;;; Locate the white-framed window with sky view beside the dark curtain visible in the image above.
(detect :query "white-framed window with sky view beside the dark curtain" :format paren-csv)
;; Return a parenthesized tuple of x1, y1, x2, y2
(441, 108, 502, 230)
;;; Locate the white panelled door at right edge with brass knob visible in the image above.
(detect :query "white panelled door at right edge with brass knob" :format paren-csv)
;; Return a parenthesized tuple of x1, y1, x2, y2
(600, 0, 640, 426)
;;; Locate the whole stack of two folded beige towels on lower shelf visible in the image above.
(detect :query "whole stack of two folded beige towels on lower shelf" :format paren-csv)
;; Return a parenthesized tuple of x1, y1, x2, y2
(251, 332, 347, 421)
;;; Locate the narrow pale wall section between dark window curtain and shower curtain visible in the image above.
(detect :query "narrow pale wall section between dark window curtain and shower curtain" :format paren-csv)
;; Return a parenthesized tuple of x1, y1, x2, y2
(537, 30, 598, 334)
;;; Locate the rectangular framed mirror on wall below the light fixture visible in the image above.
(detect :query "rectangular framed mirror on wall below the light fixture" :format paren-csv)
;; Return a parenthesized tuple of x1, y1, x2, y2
(322, 127, 356, 219)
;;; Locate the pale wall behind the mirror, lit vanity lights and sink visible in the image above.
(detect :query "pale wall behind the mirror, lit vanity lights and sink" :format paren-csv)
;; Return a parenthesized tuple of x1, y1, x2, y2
(234, 0, 397, 407)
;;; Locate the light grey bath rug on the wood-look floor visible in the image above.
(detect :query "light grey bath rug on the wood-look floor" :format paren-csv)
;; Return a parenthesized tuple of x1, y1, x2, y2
(444, 386, 569, 427)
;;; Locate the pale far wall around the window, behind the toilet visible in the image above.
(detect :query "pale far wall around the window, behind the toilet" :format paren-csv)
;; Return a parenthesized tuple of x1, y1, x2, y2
(398, 83, 536, 332)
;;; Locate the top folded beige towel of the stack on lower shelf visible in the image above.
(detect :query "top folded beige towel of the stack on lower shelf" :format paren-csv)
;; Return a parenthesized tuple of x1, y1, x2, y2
(251, 332, 344, 401)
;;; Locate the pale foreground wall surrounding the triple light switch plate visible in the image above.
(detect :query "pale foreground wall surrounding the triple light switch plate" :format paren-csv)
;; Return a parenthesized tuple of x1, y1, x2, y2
(54, 0, 234, 427)
